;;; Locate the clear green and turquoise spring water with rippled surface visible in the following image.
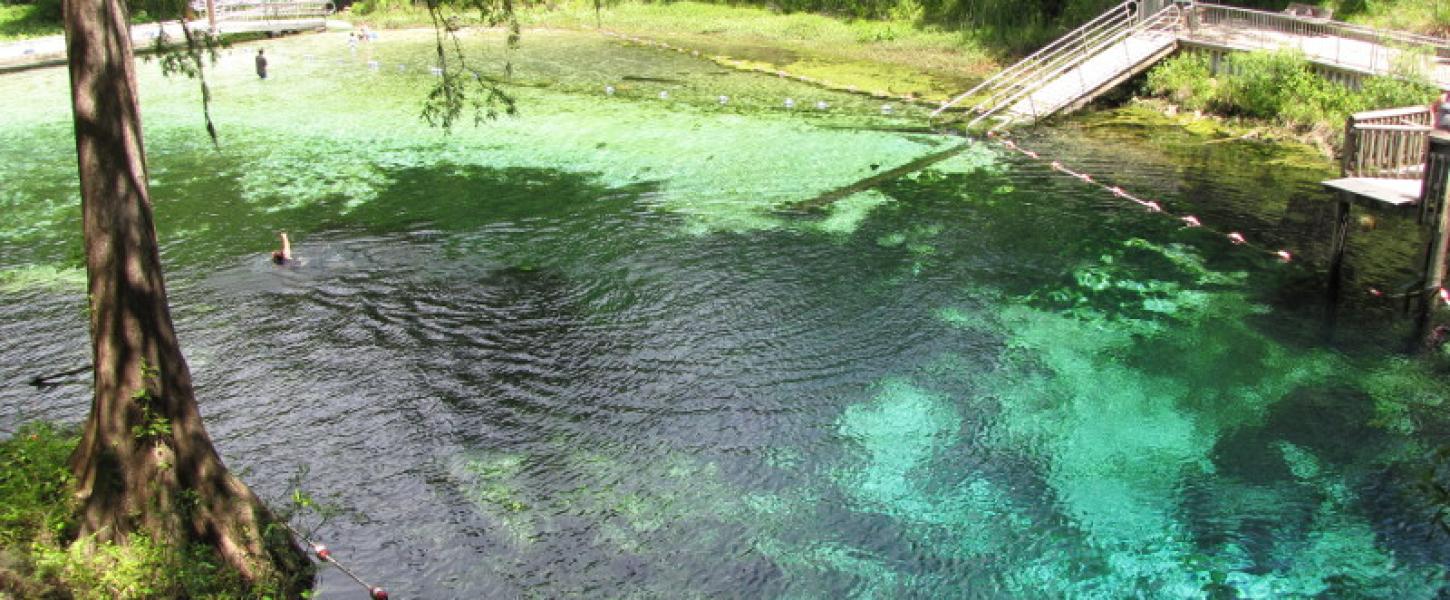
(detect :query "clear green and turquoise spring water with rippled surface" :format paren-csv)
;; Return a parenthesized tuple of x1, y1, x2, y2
(0, 26, 1450, 599)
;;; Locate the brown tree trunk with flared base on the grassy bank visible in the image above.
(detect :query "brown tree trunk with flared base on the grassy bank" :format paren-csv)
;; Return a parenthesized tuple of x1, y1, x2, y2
(64, 0, 310, 596)
